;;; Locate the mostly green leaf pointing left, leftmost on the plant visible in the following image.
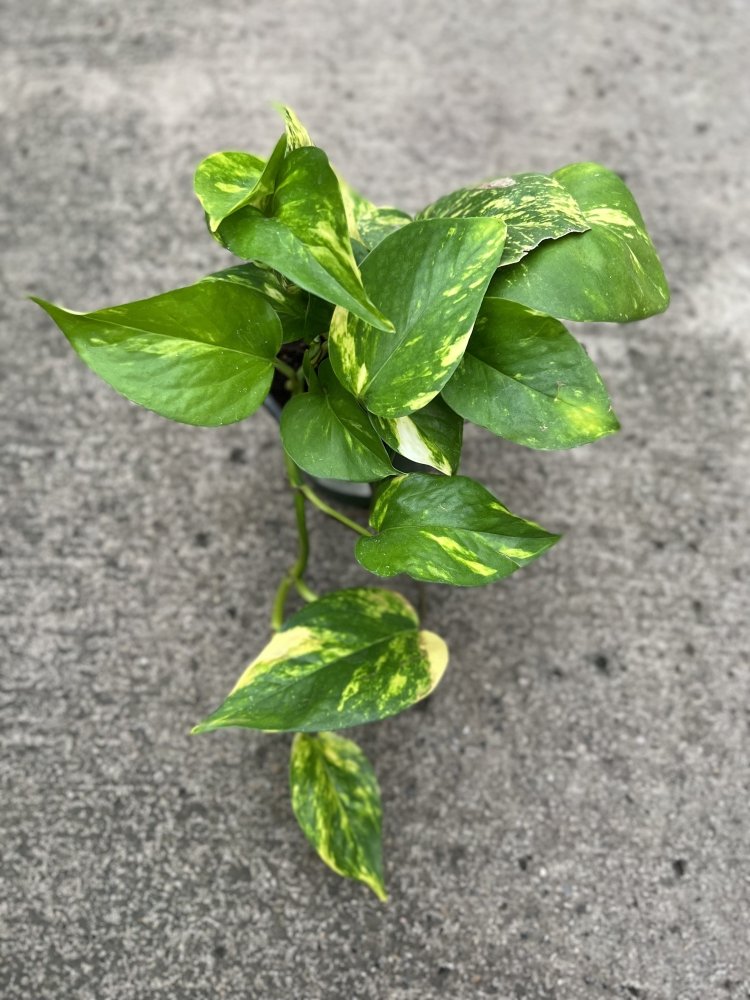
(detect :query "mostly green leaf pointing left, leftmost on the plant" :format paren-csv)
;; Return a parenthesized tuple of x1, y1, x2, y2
(28, 281, 281, 427)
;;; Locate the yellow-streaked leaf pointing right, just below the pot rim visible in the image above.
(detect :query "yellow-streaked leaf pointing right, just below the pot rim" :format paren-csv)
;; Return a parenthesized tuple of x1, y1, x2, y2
(355, 474, 559, 587)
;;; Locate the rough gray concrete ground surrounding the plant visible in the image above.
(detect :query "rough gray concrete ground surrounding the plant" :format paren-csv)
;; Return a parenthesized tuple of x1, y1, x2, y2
(0, 0, 750, 1000)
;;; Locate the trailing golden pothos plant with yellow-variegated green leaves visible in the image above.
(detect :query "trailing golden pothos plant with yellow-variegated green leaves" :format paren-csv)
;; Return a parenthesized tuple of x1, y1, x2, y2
(35, 108, 669, 899)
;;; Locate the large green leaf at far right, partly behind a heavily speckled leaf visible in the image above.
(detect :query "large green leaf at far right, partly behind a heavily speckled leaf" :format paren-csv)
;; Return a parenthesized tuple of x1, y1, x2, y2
(490, 163, 669, 323)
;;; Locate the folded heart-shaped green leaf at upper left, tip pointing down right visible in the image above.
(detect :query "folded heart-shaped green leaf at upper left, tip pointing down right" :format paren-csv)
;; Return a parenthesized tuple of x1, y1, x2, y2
(218, 146, 392, 330)
